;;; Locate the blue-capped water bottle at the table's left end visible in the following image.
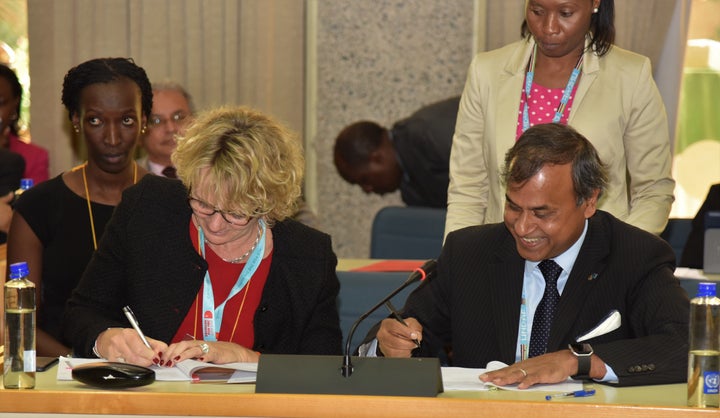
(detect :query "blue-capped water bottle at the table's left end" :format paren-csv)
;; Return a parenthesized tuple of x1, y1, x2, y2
(3, 262, 36, 389)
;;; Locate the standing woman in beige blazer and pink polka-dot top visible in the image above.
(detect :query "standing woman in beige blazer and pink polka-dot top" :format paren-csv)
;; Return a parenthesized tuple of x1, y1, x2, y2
(445, 0, 675, 235)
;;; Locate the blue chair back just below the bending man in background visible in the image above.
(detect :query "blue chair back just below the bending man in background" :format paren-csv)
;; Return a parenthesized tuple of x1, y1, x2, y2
(370, 206, 447, 260)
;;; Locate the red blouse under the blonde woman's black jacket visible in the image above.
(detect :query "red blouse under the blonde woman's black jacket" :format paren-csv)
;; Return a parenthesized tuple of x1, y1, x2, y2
(172, 222, 272, 348)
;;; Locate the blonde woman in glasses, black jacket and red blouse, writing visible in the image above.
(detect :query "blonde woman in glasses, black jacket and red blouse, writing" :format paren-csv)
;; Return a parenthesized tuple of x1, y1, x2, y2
(65, 107, 342, 366)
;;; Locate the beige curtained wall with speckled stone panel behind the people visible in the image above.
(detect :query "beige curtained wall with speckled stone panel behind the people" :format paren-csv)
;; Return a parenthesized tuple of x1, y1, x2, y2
(27, 0, 690, 257)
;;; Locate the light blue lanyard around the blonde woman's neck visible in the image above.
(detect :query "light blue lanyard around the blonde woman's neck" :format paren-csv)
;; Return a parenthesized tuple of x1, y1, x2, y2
(198, 219, 265, 341)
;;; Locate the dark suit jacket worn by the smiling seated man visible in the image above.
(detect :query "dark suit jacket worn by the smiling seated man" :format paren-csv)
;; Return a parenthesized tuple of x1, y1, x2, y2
(396, 211, 689, 386)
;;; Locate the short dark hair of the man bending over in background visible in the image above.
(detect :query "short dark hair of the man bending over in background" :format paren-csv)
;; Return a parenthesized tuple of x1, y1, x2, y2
(334, 121, 386, 167)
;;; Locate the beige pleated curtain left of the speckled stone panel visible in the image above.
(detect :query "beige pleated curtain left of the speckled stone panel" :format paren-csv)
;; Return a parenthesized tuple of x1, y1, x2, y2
(28, 0, 305, 175)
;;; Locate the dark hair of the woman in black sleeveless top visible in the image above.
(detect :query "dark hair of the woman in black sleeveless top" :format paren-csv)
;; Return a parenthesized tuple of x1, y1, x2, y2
(62, 58, 152, 120)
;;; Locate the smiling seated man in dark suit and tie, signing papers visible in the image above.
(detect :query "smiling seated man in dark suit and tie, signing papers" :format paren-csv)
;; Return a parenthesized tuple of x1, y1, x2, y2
(362, 124, 689, 388)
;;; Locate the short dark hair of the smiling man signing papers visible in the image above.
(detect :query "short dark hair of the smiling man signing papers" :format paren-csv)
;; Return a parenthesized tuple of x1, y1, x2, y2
(502, 123, 608, 206)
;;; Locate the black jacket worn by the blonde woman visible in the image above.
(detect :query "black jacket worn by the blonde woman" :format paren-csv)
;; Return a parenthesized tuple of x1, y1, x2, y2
(64, 176, 342, 357)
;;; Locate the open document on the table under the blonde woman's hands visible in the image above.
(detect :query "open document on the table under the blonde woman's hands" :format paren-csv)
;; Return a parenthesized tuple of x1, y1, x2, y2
(57, 357, 257, 383)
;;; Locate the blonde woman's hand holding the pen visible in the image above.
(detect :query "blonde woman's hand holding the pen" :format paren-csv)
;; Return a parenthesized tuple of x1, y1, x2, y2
(95, 328, 167, 366)
